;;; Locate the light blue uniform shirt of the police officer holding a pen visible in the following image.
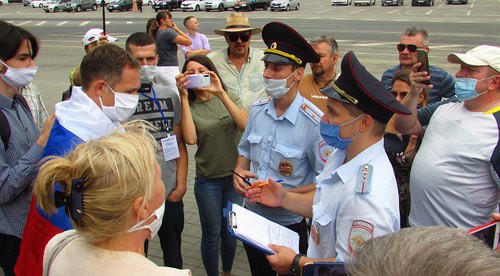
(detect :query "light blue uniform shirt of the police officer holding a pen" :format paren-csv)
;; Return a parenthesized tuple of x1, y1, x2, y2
(238, 93, 331, 225)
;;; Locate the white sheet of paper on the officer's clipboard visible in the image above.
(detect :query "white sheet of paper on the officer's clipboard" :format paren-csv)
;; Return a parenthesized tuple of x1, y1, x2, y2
(232, 204, 299, 253)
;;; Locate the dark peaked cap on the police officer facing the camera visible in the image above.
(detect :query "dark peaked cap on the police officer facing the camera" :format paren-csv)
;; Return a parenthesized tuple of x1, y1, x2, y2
(261, 22, 320, 67)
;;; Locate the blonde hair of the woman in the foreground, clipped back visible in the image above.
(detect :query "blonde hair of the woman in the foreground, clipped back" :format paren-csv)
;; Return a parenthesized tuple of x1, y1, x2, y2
(34, 121, 157, 242)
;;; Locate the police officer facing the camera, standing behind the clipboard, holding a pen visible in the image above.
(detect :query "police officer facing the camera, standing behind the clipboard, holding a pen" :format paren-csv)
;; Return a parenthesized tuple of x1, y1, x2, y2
(234, 22, 331, 276)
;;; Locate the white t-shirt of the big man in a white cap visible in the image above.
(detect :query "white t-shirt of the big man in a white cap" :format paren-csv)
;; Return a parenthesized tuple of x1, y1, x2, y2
(410, 102, 500, 229)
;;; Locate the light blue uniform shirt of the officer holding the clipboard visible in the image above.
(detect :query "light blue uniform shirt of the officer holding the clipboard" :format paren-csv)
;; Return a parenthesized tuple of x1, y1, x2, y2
(307, 139, 399, 261)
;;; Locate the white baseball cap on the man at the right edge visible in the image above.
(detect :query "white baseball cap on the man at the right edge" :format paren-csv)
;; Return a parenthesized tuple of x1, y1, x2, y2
(448, 45, 500, 72)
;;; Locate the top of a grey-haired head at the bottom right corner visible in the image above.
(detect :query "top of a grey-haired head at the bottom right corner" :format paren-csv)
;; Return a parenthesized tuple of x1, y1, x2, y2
(347, 226, 500, 276)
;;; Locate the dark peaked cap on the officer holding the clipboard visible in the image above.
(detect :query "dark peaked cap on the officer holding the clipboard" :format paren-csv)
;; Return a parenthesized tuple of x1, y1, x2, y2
(320, 51, 411, 124)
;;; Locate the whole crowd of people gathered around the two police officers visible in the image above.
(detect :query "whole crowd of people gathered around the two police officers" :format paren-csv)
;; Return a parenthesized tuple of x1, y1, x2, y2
(0, 10, 500, 276)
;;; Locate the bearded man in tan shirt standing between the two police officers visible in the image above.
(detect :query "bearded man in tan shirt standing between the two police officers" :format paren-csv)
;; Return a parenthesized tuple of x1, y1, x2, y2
(299, 35, 339, 112)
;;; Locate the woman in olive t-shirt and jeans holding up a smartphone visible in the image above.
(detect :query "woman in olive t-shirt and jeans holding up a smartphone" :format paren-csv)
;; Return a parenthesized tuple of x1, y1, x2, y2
(176, 55, 248, 276)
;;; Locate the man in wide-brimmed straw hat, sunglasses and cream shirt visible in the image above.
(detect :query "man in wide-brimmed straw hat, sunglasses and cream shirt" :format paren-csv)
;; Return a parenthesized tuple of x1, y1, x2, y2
(208, 13, 266, 111)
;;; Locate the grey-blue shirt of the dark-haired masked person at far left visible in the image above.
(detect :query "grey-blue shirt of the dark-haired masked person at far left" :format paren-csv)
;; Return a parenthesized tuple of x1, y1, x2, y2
(0, 95, 43, 238)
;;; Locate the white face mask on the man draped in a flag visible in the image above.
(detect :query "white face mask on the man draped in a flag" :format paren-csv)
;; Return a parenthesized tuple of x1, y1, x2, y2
(99, 84, 139, 122)
